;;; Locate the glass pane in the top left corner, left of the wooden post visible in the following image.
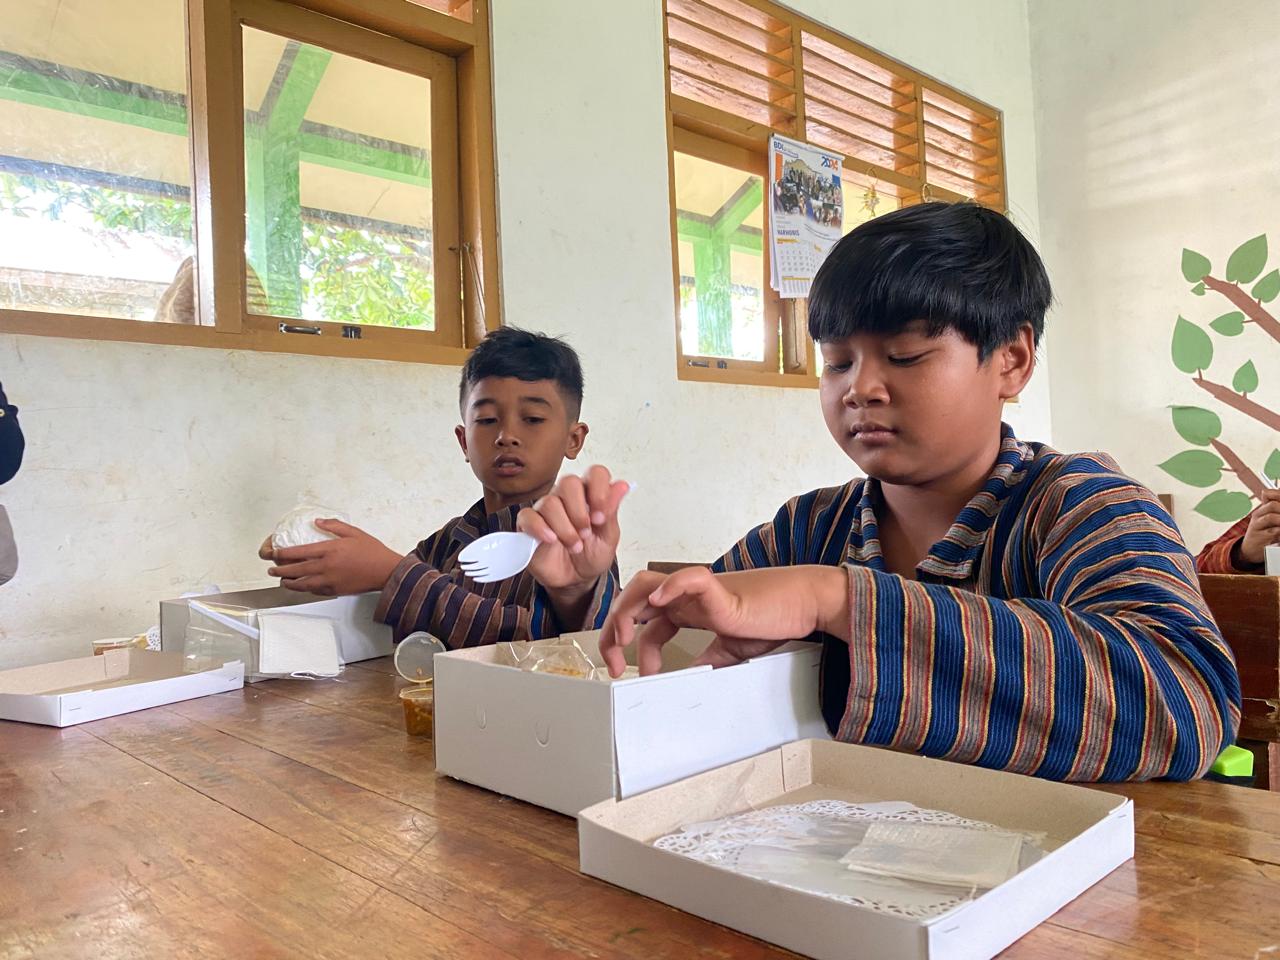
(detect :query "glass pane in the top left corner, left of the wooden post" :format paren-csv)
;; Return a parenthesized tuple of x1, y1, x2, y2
(0, 0, 196, 323)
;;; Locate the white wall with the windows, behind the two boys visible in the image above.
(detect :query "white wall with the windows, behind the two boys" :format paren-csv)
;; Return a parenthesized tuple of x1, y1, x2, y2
(0, 0, 1052, 667)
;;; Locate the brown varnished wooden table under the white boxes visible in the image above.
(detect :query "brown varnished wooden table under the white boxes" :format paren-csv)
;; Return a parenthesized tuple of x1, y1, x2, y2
(0, 660, 1280, 960)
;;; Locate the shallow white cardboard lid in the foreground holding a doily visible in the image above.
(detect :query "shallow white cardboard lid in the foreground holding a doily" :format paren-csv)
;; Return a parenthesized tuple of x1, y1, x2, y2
(579, 740, 1133, 960)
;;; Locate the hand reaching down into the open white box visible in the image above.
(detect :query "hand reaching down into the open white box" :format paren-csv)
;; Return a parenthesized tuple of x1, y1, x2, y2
(600, 566, 849, 677)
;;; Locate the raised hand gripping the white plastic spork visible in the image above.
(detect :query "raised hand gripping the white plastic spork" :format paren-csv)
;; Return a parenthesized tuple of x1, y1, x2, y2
(516, 466, 631, 599)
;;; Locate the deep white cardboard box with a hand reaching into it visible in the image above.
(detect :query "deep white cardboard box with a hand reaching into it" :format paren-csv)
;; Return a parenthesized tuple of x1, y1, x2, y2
(435, 630, 827, 815)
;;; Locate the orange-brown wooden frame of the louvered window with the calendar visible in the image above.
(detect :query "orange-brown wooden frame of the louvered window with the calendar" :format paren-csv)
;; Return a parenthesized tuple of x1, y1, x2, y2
(662, 0, 1009, 388)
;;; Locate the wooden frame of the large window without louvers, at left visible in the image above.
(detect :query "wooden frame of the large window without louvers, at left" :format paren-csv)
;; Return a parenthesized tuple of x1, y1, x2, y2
(0, 0, 502, 365)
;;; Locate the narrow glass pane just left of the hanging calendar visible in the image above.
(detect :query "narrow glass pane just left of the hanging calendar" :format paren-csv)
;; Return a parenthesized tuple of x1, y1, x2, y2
(676, 152, 764, 361)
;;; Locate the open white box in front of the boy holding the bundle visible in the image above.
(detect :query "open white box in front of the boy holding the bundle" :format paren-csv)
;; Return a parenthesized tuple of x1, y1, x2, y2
(160, 586, 396, 682)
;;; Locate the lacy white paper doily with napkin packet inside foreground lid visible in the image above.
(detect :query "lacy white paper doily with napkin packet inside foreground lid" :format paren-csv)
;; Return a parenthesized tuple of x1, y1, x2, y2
(654, 800, 1044, 919)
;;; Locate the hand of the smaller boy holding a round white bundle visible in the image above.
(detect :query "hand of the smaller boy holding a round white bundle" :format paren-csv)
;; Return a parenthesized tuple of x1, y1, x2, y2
(264, 520, 403, 596)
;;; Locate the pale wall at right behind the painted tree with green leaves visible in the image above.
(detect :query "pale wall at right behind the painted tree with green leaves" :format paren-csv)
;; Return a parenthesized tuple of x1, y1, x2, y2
(1030, 0, 1280, 549)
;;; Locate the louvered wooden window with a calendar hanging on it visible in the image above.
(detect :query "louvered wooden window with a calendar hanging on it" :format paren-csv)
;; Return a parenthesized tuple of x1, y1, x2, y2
(664, 0, 1005, 387)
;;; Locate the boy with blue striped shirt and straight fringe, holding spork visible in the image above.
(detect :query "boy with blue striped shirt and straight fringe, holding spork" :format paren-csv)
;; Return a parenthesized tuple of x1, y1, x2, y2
(520, 204, 1240, 781)
